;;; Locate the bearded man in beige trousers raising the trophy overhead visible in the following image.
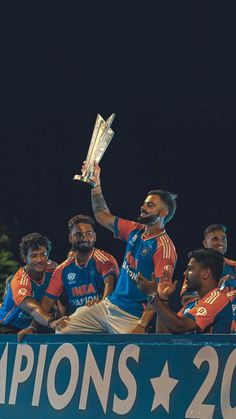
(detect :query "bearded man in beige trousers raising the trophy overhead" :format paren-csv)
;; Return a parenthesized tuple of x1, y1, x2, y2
(56, 162, 176, 333)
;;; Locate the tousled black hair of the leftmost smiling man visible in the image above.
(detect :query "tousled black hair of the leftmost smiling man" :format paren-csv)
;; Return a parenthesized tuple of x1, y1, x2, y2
(19, 233, 52, 260)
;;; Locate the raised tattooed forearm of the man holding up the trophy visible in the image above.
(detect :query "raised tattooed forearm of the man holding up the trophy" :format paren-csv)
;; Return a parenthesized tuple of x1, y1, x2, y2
(91, 185, 115, 232)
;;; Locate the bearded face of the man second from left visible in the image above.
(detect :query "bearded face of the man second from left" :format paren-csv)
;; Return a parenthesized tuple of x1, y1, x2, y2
(69, 223, 96, 253)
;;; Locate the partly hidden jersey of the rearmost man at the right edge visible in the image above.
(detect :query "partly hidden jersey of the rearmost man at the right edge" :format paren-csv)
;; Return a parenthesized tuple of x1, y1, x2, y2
(180, 258, 236, 333)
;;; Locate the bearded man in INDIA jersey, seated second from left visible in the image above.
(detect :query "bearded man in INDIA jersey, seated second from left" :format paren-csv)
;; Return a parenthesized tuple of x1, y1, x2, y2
(18, 215, 119, 341)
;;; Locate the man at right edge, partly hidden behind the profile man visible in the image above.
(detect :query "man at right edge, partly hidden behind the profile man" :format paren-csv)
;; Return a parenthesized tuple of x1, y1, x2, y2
(181, 224, 236, 333)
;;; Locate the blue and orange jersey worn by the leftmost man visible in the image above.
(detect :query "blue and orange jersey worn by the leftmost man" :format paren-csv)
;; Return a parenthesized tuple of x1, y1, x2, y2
(0, 260, 57, 329)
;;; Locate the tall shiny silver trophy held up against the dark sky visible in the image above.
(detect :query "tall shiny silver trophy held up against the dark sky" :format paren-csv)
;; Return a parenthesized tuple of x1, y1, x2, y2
(74, 113, 115, 187)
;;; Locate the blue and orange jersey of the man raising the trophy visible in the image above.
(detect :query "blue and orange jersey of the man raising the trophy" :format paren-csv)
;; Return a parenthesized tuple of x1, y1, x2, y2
(109, 217, 177, 317)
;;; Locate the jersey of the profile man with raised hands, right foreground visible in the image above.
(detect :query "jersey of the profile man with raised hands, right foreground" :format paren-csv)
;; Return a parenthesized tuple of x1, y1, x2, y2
(177, 288, 232, 333)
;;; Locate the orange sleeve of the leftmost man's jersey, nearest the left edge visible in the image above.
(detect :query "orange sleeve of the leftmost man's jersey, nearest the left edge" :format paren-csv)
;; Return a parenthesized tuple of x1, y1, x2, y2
(11, 269, 33, 306)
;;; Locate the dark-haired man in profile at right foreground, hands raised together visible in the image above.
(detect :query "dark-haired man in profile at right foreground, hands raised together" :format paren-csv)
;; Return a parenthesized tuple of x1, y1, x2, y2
(138, 249, 232, 333)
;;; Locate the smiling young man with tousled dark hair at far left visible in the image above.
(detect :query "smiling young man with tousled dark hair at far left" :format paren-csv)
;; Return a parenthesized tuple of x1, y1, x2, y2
(0, 233, 57, 333)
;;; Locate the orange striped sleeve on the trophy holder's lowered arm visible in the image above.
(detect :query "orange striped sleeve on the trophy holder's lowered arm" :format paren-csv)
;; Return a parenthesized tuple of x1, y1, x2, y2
(153, 240, 177, 280)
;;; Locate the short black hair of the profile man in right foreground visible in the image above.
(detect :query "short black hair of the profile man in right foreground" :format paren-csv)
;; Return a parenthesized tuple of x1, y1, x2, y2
(188, 248, 224, 284)
